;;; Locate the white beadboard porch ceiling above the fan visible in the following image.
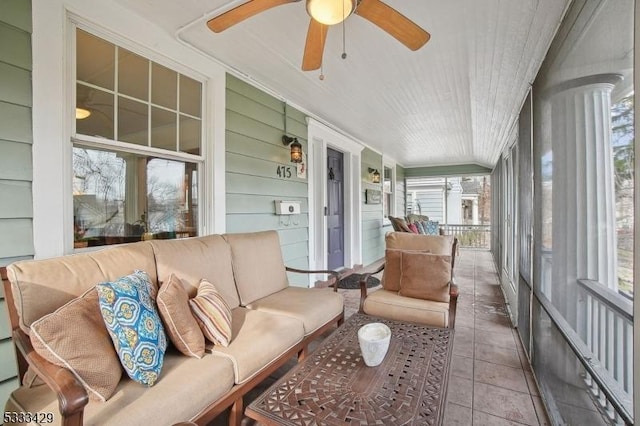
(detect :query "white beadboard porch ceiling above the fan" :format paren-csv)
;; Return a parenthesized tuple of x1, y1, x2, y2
(118, 0, 568, 168)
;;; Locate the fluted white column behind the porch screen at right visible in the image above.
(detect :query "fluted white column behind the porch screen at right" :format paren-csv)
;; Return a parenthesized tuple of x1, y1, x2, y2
(542, 74, 620, 328)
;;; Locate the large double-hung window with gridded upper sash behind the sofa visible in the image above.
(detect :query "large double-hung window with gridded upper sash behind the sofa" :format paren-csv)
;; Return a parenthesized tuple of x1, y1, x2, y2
(73, 29, 204, 248)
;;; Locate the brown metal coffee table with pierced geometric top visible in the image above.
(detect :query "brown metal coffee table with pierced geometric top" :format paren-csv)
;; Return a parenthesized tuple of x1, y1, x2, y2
(245, 314, 453, 426)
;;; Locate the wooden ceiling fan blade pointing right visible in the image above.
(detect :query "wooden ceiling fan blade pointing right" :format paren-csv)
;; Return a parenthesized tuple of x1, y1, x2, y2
(355, 0, 431, 50)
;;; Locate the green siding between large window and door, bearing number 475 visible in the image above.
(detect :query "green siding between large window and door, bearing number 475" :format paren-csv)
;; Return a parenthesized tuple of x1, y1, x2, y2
(226, 75, 309, 286)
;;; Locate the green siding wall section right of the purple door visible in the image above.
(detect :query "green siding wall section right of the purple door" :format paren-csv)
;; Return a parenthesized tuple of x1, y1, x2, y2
(361, 148, 384, 265)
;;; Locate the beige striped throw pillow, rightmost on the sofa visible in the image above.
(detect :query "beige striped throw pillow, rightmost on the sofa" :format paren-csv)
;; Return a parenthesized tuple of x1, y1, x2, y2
(189, 280, 231, 346)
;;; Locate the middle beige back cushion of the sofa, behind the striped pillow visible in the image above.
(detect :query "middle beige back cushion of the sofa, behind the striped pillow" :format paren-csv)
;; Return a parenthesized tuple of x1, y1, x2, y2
(151, 235, 240, 309)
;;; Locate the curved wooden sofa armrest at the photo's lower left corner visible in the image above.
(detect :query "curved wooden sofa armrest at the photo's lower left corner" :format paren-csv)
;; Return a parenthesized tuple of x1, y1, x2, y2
(13, 329, 89, 425)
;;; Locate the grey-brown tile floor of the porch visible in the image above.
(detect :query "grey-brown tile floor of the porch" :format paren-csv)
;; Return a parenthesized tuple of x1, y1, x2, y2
(220, 249, 550, 426)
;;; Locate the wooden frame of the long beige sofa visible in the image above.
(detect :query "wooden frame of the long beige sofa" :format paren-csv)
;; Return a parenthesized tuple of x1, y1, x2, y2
(0, 267, 344, 426)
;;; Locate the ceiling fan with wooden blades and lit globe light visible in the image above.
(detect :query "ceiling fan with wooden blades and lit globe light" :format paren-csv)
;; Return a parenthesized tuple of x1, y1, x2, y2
(207, 0, 431, 71)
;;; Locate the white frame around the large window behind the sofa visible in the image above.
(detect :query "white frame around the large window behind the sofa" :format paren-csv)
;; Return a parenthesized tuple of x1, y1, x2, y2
(72, 21, 208, 253)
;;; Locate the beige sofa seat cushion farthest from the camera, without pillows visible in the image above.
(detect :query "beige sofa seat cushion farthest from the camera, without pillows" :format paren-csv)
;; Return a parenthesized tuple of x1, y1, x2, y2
(247, 287, 344, 336)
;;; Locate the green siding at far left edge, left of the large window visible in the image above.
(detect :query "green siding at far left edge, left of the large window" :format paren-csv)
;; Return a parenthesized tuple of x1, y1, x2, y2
(0, 0, 33, 405)
